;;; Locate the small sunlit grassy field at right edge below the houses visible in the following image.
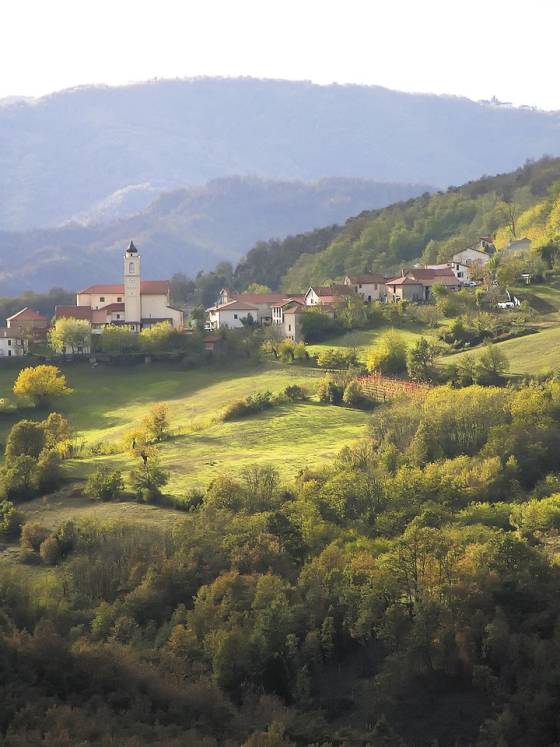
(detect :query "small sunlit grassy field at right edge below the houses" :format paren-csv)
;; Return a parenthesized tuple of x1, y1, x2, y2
(440, 326, 560, 374)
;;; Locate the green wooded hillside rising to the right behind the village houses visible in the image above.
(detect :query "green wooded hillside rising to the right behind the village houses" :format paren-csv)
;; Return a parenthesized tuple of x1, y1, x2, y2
(234, 158, 560, 290)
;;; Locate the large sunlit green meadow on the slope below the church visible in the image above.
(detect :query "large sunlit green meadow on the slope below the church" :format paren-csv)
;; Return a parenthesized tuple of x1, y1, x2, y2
(0, 364, 369, 510)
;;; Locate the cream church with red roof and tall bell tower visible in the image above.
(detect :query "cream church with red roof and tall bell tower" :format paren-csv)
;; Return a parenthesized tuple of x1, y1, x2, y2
(55, 241, 183, 332)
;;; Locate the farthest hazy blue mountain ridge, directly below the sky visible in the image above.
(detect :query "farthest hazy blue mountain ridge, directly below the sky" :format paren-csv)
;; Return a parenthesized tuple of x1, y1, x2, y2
(0, 78, 560, 231)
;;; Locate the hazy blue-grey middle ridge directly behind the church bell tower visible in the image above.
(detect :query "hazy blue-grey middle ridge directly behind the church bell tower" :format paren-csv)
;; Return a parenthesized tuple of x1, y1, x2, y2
(0, 177, 429, 294)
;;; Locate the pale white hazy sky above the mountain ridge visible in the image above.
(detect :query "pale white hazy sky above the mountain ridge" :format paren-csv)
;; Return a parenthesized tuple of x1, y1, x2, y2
(0, 0, 560, 109)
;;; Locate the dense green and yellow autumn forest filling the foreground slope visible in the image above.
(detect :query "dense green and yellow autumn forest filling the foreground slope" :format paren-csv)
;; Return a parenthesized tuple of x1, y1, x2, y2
(0, 377, 560, 747)
